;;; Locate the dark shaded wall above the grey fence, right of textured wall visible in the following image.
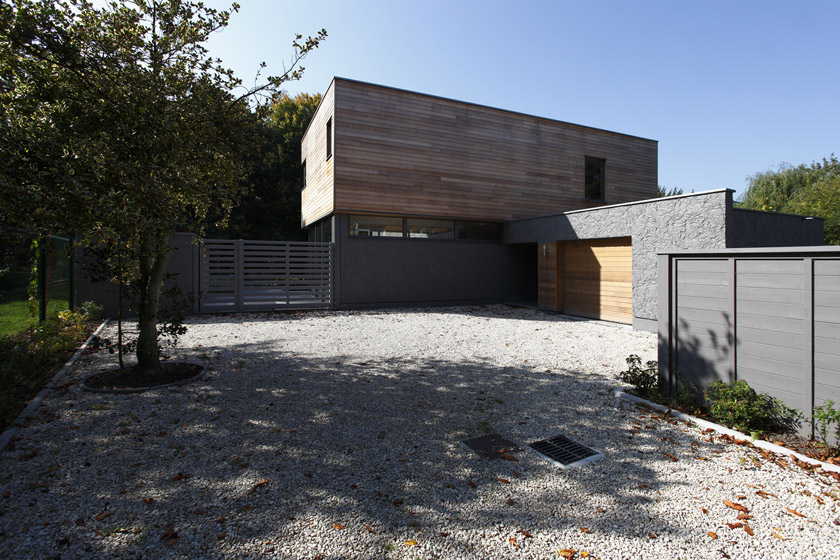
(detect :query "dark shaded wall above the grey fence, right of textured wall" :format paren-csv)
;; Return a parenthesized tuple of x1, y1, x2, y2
(726, 208, 825, 247)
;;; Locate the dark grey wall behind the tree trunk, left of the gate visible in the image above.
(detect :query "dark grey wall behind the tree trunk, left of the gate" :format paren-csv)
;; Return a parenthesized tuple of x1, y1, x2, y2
(76, 233, 198, 317)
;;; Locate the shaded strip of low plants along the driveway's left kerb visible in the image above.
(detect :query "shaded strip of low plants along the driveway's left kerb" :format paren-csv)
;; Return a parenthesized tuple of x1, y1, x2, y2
(0, 311, 94, 430)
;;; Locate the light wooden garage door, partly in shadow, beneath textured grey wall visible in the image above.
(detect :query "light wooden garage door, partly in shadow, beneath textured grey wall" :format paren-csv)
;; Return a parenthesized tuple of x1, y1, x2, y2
(562, 237, 633, 323)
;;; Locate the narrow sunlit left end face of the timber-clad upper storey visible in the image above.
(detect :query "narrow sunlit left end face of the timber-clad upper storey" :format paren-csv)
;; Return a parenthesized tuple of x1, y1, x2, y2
(300, 82, 335, 227)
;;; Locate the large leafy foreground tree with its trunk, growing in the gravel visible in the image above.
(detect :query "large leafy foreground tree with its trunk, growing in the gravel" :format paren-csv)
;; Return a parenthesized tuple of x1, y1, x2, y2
(0, 0, 326, 371)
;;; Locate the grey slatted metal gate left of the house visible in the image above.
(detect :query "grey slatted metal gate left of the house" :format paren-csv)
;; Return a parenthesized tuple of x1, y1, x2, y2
(199, 239, 334, 313)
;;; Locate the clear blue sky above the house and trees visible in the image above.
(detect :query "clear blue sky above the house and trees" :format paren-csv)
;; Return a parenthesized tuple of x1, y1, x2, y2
(206, 0, 840, 199)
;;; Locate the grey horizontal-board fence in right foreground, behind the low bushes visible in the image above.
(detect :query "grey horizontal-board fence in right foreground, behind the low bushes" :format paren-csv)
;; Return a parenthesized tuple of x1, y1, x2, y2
(658, 247, 840, 440)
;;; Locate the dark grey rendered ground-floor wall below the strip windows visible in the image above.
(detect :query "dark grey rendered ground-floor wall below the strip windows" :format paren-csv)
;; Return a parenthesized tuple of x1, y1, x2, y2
(333, 214, 537, 309)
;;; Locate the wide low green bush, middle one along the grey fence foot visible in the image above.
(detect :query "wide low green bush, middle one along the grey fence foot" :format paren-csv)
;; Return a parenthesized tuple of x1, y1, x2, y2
(704, 380, 802, 435)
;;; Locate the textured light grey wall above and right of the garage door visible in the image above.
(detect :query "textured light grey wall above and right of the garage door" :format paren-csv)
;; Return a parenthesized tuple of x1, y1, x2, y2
(504, 190, 732, 321)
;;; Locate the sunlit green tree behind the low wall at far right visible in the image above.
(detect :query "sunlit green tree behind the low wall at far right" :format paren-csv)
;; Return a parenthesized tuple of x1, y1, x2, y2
(739, 154, 840, 245)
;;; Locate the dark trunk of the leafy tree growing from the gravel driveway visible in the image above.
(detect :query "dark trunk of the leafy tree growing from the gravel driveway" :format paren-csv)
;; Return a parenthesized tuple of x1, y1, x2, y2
(137, 235, 170, 373)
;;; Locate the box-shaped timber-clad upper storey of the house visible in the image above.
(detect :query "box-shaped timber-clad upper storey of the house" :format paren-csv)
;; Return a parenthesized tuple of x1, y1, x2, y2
(302, 78, 657, 226)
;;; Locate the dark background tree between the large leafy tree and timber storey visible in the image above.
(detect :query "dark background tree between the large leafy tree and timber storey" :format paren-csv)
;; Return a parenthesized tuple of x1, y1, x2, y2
(208, 93, 321, 241)
